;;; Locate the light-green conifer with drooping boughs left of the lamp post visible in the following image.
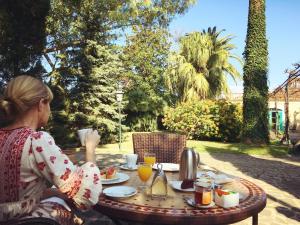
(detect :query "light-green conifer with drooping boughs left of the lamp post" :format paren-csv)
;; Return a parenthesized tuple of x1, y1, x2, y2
(70, 41, 123, 142)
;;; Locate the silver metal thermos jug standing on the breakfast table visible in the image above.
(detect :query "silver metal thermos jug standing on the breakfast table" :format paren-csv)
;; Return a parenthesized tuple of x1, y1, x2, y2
(179, 148, 200, 180)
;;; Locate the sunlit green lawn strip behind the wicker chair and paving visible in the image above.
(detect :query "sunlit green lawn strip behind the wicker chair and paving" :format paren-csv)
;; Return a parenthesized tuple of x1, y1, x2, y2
(97, 133, 288, 157)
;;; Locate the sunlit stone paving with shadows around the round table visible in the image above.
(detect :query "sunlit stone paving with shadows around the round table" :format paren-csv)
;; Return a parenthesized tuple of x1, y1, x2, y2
(70, 147, 300, 225)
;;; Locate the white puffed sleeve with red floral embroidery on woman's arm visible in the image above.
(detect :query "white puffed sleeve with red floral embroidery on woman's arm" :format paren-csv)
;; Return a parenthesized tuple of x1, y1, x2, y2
(30, 132, 102, 209)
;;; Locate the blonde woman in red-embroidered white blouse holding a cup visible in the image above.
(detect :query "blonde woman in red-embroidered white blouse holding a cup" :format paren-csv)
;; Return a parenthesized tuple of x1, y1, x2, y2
(0, 76, 102, 224)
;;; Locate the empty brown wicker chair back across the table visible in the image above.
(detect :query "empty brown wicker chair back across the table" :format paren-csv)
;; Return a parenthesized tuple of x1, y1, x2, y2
(132, 132, 186, 163)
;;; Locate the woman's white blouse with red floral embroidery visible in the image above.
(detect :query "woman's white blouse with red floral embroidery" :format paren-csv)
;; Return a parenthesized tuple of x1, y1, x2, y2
(0, 128, 102, 222)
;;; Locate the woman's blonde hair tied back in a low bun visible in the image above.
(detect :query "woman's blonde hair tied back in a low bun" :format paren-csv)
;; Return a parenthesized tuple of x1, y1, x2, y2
(0, 75, 53, 123)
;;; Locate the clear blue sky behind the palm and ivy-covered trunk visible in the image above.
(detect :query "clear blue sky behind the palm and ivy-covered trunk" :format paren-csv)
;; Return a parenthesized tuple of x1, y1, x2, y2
(170, 0, 300, 93)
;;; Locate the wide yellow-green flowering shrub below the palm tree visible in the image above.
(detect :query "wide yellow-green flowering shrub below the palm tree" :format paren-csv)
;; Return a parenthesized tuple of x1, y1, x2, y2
(163, 100, 242, 141)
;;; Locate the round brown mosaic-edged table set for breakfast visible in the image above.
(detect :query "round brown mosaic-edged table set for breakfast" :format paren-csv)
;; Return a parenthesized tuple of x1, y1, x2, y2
(95, 171, 266, 225)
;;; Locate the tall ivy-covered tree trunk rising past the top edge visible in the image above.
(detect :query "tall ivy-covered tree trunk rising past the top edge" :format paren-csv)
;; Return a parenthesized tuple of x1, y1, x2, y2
(243, 0, 269, 143)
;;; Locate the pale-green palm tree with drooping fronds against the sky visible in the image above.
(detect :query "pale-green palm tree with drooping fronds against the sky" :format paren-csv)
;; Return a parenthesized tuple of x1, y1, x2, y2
(166, 27, 242, 102)
